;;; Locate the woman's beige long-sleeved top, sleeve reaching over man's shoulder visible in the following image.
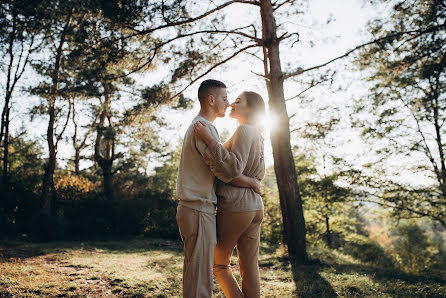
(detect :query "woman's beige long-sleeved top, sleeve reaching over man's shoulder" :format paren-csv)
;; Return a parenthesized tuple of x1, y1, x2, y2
(205, 124, 265, 212)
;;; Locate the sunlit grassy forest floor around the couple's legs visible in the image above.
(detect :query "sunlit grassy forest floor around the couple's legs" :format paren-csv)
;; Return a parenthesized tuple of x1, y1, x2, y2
(0, 238, 446, 298)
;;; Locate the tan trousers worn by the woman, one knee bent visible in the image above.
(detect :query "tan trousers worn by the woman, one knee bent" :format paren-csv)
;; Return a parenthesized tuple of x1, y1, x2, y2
(214, 210, 263, 298)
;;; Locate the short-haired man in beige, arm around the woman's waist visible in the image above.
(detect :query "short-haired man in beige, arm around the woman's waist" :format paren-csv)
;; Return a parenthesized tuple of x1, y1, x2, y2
(176, 80, 260, 298)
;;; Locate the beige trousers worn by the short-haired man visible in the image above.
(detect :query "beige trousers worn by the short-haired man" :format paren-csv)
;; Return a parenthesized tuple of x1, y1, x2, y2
(176, 205, 217, 298)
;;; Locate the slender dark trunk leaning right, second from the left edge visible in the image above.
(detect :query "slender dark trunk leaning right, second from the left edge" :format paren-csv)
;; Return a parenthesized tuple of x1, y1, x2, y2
(41, 9, 74, 217)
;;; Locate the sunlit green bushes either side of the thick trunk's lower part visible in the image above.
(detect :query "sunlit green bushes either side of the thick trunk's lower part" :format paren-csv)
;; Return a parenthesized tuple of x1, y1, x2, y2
(261, 154, 365, 248)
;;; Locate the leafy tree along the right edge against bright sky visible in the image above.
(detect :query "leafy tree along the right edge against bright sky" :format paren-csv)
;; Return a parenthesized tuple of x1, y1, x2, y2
(352, 0, 446, 226)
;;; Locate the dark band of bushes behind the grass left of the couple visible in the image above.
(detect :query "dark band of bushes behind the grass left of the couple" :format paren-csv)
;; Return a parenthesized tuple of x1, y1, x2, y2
(0, 137, 179, 239)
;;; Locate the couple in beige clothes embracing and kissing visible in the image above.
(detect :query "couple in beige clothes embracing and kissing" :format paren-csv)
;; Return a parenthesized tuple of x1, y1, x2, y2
(176, 80, 265, 298)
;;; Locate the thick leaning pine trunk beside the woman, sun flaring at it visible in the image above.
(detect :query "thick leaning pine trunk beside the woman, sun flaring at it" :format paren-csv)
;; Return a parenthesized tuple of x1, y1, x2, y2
(261, 0, 308, 264)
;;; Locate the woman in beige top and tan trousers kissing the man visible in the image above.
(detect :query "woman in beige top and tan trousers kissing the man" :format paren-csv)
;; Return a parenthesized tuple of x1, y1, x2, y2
(194, 91, 265, 297)
